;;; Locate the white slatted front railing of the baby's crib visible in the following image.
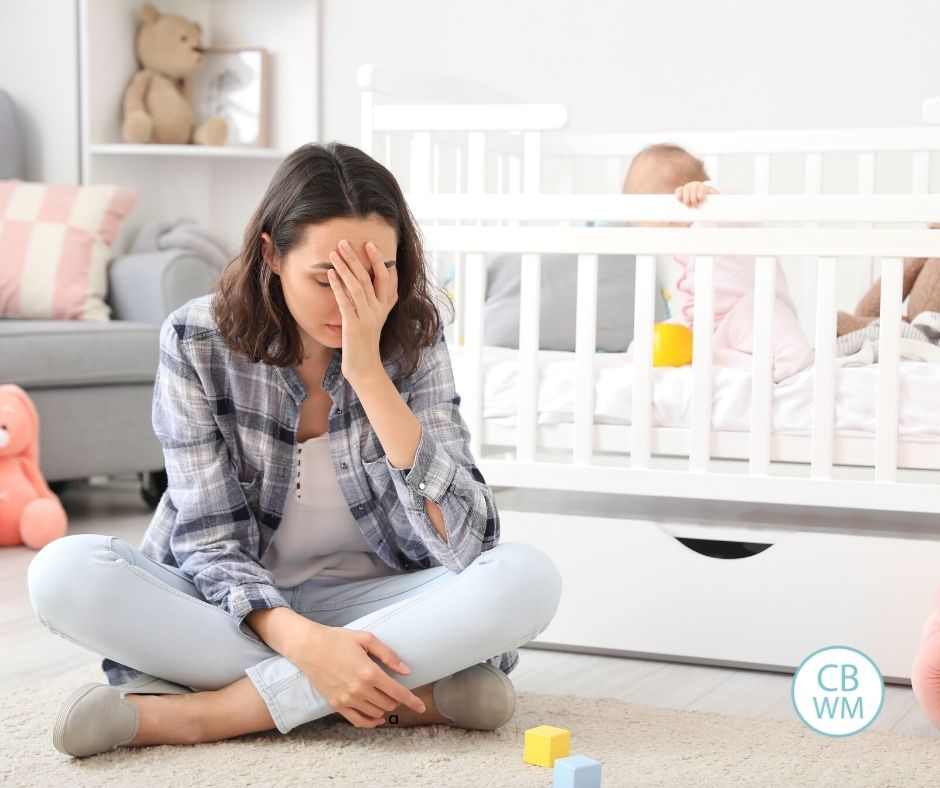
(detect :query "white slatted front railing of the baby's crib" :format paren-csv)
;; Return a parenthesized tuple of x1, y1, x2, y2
(410, 195, 940, 512)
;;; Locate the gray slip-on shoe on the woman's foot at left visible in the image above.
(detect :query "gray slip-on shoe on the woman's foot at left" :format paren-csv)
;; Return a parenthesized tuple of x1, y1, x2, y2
(52, 676, 192, 758)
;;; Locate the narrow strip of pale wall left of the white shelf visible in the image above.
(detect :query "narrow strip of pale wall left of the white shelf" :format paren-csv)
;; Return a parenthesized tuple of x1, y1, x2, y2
(0, 0, 79, 183)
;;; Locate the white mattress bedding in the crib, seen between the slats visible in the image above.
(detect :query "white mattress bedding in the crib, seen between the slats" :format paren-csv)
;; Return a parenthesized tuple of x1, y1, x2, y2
(450, 347, 940, 443)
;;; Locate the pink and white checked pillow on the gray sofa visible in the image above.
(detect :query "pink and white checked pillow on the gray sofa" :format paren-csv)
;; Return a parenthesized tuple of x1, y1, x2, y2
(0, 181, 138, 320)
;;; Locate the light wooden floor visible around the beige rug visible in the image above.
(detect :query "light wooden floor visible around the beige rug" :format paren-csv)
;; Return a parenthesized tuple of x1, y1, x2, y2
(0, 478, 940, 738)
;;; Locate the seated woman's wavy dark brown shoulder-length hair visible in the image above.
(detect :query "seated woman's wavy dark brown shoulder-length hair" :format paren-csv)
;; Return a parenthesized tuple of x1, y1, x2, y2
(213, 143, 450, 377)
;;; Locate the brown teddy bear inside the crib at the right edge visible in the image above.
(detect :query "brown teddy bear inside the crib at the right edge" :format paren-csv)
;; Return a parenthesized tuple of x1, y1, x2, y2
(836, 224, 940, 338)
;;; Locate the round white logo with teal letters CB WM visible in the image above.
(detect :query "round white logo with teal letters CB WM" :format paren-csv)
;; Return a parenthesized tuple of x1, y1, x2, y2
(790, 646, 885, 736)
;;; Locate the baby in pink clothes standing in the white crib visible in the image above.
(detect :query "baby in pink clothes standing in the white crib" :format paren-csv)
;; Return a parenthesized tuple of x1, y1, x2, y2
(623, 144, 813, 382)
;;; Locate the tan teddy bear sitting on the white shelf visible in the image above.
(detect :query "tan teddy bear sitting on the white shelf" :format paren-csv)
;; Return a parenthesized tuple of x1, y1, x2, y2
(122, 3, 228, 145)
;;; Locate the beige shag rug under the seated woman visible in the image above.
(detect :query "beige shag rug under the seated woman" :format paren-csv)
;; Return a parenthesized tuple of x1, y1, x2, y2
(0, 666, 940, 788)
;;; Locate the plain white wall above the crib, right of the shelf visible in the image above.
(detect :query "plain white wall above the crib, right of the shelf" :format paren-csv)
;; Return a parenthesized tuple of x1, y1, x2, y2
(321, 0, 940, 143)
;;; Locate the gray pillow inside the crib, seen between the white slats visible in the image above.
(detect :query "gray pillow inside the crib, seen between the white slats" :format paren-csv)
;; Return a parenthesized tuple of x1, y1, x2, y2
(483, 254, 669, 353)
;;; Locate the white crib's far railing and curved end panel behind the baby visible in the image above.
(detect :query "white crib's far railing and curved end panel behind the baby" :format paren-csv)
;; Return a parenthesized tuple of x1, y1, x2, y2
(358, 66, 940, 336)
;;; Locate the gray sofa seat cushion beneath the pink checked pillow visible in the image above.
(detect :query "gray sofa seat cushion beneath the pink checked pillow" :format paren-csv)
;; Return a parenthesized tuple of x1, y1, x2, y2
(0, 318, 160, 388)
